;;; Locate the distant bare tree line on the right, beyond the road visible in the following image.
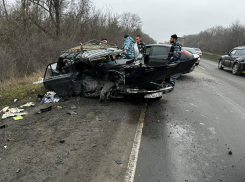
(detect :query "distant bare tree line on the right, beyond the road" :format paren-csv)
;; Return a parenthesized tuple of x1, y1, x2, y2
(184, 21, 245, 54)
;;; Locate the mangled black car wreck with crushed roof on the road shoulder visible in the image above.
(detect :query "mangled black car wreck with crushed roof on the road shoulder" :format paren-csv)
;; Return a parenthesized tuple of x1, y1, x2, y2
(43, 41, 197, 101)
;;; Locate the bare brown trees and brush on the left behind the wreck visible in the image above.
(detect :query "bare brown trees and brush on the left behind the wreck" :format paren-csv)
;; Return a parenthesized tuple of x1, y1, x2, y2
(0, 0, 155, 84)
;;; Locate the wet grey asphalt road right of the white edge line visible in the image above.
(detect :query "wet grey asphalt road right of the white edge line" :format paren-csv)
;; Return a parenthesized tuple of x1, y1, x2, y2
(134, 59, 245, 182)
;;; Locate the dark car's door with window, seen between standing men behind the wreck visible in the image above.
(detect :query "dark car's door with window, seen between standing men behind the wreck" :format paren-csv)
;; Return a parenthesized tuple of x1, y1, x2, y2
(148, 46, 170, 66)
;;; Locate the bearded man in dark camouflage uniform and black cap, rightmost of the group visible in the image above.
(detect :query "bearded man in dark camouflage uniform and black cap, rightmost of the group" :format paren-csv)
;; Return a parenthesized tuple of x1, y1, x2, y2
(168, 34, 181, 88)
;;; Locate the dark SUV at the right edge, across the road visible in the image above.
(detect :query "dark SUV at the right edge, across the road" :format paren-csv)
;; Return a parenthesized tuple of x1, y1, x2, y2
(218, 46, 245, 75)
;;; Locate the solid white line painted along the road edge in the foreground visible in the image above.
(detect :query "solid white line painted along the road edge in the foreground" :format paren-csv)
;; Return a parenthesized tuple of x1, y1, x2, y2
(124, 103, 147, 182)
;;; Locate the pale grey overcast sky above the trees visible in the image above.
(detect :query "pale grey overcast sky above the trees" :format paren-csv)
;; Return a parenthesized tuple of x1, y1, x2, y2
(93, 0, 245, 42)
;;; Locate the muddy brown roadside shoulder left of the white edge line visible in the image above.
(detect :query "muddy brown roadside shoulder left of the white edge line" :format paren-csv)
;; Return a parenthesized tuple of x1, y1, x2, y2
(0, 97, 143, 182)
